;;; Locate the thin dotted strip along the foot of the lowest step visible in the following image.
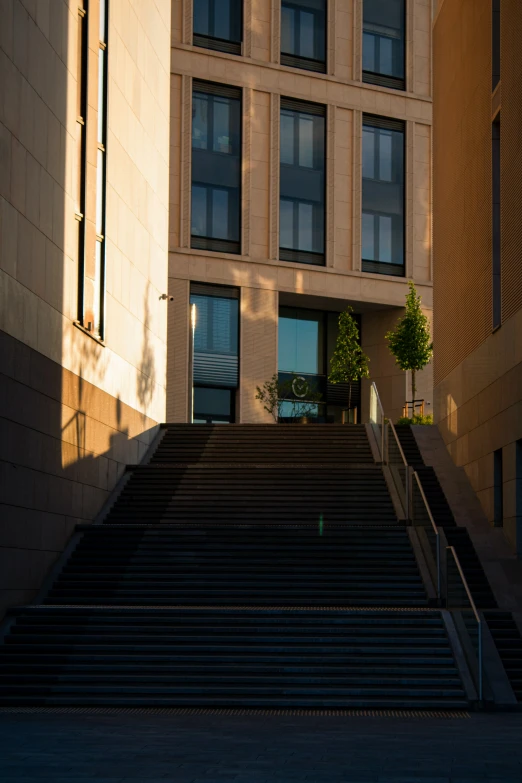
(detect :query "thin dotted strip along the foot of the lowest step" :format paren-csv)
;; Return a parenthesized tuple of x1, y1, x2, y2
(0, 707, 470, 720)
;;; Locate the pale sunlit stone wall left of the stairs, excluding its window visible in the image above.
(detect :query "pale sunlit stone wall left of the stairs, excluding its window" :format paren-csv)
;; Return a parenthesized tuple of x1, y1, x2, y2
(0, 0, 170, 613)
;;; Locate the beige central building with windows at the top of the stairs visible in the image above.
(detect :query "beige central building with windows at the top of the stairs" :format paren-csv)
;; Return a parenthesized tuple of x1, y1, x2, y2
(167, 0, 432, 422)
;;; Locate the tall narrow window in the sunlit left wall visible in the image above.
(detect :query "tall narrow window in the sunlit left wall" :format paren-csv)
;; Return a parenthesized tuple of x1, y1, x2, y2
(76, 0, 108, 338)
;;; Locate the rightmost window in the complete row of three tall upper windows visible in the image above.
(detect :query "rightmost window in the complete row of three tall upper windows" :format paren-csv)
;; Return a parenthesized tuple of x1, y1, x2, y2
(362, 115, 404, 276)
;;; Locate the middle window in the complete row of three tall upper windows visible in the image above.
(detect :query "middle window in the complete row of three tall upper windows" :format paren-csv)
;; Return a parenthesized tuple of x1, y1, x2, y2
(279, 98, 325, 265)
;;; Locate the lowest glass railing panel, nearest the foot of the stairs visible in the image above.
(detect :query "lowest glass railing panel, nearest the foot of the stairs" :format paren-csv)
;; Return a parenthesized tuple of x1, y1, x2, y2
(446, 546, 484, 701)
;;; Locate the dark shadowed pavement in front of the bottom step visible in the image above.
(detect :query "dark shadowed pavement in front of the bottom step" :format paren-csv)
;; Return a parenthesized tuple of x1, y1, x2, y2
(0, 713, 522, 783)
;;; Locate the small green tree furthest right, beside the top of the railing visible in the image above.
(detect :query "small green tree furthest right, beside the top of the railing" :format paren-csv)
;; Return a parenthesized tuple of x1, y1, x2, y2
(386, 280, 433, 404)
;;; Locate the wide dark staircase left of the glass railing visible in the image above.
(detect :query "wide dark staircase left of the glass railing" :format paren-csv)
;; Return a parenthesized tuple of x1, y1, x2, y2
(0, 425, 468, 709)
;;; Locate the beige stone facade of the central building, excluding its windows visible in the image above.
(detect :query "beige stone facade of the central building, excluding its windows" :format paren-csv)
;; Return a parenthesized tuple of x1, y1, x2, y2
(167, 0, 432, 422)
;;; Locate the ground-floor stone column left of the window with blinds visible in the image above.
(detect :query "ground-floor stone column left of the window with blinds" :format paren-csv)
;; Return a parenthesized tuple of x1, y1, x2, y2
(167, 278, 190, 423)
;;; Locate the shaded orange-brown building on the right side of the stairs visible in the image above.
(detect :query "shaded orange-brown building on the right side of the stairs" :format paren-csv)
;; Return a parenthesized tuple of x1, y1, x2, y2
(433, 0, 522, 555)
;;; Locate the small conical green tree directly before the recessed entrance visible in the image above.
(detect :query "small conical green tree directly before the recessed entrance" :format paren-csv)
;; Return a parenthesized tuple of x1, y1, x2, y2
(328, 307, 370, 410)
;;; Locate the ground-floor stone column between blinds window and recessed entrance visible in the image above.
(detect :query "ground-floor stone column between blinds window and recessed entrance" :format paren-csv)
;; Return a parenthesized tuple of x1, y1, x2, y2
(238, 288, 279, 424)
